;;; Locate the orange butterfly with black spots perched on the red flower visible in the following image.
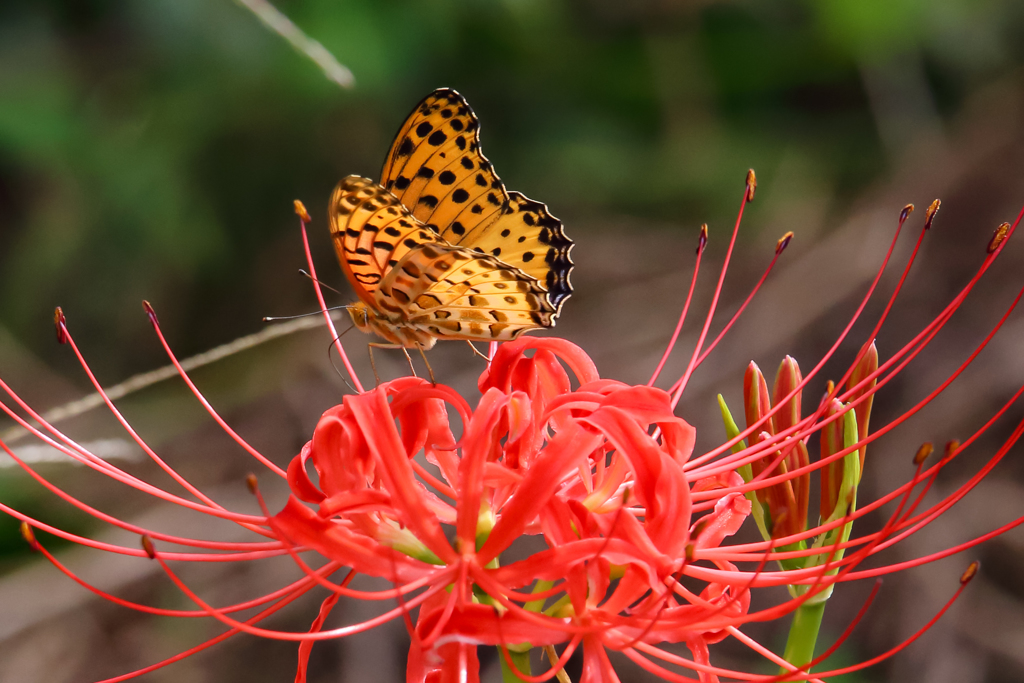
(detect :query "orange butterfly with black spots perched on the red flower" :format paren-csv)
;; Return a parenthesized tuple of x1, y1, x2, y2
(328, 88, 572, 356)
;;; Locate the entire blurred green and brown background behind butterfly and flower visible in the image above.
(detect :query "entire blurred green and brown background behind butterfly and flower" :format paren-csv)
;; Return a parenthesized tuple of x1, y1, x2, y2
(0, 0, 1024, 683)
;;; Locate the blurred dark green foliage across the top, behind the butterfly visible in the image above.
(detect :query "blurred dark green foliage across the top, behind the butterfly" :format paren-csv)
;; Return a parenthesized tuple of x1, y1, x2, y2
(0, 0, 1024, 377)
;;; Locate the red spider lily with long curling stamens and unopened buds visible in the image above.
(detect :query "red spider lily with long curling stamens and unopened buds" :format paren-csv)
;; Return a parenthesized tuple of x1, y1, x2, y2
(0, 174, 1024, 683)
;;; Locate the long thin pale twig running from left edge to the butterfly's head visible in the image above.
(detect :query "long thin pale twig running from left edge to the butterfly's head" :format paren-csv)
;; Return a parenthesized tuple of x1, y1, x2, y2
(0, 316, 324, 443)
